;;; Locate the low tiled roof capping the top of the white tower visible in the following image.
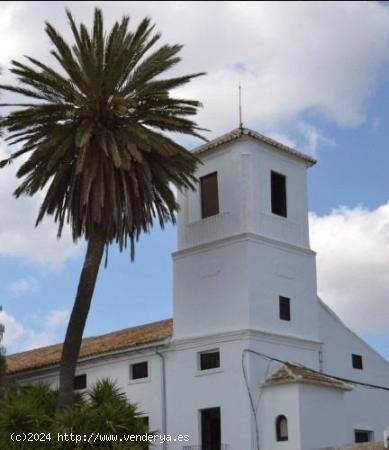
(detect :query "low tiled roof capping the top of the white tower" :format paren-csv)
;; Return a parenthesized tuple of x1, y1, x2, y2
(193, 128, 317, 166)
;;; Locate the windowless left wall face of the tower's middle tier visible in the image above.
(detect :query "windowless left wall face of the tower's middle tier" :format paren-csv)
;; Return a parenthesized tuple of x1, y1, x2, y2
(173, 238, 249, 339)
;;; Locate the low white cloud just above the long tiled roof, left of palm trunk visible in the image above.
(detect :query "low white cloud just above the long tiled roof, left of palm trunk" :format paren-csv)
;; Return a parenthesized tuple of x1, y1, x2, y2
(0, 310, 69, 354)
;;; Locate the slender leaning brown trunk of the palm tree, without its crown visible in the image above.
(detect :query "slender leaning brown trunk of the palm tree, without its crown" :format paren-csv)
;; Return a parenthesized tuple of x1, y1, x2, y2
(57, 232, 105, 411)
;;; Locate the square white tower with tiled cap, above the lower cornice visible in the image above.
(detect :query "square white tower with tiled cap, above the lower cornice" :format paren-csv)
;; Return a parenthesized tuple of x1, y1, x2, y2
(173, 129, 318, 339)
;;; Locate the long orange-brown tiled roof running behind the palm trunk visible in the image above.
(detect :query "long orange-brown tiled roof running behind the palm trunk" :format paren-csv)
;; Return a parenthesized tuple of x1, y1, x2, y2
(7, 319, 173, 374)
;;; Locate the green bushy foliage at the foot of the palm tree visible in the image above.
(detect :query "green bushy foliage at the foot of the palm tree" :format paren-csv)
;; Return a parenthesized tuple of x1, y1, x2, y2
(0, 380, 152, 450)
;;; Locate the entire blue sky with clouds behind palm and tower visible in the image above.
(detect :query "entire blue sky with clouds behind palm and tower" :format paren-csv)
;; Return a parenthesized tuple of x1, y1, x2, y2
(0, 2, 389, 358)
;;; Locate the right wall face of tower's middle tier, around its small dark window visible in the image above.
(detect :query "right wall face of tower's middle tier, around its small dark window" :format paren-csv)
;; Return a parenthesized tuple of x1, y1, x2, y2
(248, 238, 318, 339)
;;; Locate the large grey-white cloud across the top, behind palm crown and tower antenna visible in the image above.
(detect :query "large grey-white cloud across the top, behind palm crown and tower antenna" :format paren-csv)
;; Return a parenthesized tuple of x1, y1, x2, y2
(0, 1, 389, 133)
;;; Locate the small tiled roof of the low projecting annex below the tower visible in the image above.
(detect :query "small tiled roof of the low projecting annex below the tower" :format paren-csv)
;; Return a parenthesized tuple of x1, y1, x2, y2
(266, 363, 352, 391)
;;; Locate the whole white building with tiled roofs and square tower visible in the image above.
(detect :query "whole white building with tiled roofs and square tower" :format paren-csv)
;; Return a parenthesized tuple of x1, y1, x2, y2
(8, 129, 389, 450)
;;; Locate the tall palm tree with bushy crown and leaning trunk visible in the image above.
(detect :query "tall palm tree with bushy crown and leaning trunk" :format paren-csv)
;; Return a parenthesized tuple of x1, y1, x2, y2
(0, 9, 202, 409)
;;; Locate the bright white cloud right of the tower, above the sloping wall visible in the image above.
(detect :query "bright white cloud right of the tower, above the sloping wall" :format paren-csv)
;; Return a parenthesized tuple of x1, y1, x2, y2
(310, 203, 389, 334)
